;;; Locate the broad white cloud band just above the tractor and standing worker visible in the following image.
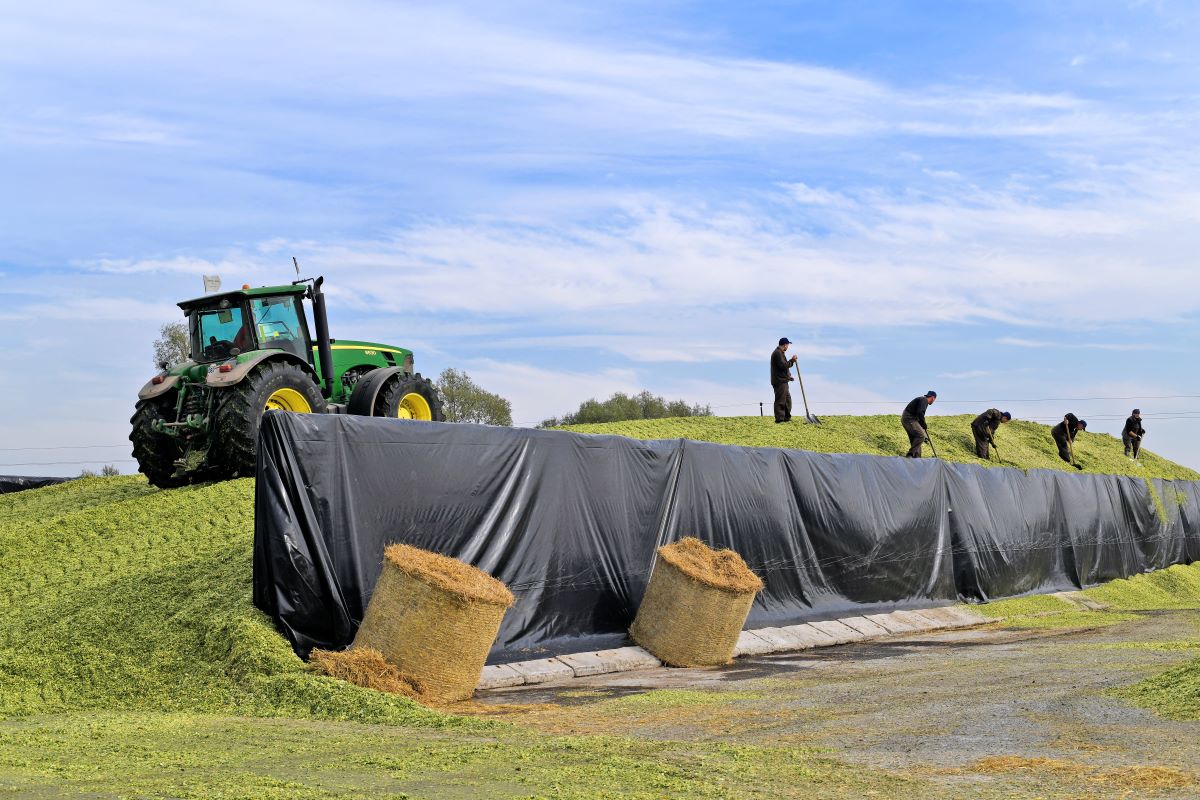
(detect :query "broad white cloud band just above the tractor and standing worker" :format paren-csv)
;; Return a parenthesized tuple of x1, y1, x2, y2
(82, 160, 1200, 340)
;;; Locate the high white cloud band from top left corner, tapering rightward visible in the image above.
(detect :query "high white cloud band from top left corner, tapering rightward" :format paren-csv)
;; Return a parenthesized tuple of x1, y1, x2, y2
(0, 0, 1161, 155)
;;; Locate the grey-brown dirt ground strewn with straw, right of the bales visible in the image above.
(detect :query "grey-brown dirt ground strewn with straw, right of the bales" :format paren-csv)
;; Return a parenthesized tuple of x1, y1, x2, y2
(479, 612, 1200, 798)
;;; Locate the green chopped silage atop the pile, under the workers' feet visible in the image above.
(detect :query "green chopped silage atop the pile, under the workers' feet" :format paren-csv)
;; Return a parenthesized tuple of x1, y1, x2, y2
(564, 414, 1200, 480)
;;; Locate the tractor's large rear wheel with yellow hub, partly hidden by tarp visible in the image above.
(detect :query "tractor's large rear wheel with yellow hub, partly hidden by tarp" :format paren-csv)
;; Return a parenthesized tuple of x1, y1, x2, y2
(210, 361, 326, 477)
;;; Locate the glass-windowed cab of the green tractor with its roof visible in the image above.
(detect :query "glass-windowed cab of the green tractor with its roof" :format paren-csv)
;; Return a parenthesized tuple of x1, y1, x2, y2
(179, 287, 312, 363)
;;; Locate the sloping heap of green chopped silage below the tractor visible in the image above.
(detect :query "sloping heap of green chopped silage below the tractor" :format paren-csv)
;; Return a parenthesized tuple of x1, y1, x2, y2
(0, 476, 481, 726)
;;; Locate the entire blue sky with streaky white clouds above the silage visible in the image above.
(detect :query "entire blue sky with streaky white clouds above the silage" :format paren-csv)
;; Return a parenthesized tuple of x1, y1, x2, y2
(0, 0, 1200, 474)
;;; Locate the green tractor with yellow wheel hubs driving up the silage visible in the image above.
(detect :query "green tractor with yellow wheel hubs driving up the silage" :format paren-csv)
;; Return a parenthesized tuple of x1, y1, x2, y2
(130, 278, 444, 488)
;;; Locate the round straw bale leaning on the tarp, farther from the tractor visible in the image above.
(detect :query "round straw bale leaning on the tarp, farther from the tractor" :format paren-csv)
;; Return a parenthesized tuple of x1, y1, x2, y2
(629, 536, 762, 667)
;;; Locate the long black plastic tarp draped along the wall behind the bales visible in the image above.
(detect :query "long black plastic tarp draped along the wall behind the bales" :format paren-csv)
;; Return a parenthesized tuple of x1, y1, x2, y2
(254, 413, 1200, 663)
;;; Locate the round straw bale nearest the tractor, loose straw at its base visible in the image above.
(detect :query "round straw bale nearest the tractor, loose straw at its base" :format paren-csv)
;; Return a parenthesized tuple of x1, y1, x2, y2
(352, 545, 512, 703)
